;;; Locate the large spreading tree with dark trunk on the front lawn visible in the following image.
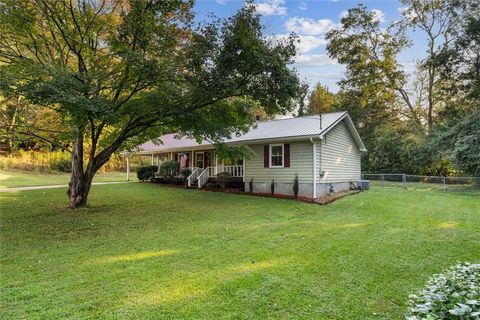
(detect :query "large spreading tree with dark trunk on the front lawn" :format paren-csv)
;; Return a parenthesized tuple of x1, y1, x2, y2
(0, 0, 299, 208)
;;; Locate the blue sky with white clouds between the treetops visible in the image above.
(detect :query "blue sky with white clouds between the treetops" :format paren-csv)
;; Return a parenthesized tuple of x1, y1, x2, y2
(194, 0, 425, 92)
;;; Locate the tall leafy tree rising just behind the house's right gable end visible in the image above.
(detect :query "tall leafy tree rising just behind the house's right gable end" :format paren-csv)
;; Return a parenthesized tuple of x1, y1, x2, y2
(326, 5, 417, 148)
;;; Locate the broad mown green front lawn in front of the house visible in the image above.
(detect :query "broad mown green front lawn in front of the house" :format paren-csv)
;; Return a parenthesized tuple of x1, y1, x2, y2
(0, 183, 480, 319)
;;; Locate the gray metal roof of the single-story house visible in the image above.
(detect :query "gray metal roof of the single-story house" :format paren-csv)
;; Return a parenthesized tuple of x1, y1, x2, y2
(133, 112, 365, 153)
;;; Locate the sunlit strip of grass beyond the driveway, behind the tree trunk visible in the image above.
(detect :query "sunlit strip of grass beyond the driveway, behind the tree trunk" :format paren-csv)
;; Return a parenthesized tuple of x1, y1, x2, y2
(0, 170, 126, 188)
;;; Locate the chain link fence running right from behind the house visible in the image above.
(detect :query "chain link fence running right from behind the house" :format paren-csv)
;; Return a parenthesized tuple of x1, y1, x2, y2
(362, 173, 480, 193)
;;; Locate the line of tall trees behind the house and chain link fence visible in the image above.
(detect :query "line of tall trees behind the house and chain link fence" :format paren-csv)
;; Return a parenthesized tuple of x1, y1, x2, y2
(298, 0, 480, 176)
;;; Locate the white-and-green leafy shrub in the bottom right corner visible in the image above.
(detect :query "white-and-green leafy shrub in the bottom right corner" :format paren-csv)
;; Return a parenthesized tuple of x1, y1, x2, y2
(405, 262, 480, 320)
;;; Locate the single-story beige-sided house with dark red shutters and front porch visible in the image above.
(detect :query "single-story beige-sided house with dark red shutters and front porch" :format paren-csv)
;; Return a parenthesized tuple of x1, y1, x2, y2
(129, 112, 366, 198)
